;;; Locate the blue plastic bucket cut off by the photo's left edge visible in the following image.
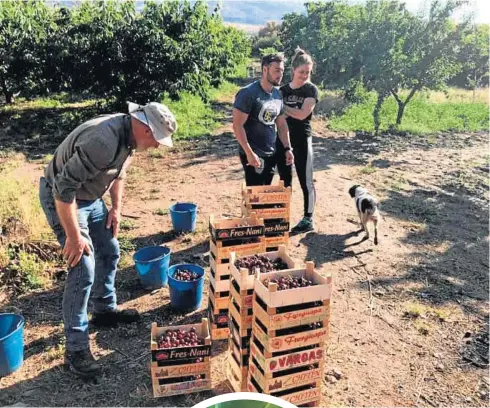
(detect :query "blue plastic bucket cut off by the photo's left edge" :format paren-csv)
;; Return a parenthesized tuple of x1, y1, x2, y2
(0, 313, 24, 377)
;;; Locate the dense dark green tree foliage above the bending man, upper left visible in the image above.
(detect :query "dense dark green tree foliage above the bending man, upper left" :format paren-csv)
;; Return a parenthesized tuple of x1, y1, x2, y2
(0, 0, 250, 104)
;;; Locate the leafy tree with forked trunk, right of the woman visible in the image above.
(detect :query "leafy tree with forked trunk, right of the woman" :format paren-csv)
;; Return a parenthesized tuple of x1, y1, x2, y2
(280, 0, 488, 131)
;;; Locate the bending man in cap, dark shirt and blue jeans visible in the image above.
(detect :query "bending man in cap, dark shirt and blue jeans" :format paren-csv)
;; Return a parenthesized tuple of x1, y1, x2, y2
(39, 102, 177, 377)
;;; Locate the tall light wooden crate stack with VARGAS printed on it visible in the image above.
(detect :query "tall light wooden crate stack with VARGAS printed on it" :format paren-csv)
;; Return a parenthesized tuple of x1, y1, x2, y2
(248, 262, 332, 406)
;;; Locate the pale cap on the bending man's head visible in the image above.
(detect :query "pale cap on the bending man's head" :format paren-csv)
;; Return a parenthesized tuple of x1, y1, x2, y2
(128, 102, 177, 147)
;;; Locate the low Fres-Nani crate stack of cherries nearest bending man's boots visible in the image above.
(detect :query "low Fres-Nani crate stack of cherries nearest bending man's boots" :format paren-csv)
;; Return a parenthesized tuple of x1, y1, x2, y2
(150, 319, 211, 397)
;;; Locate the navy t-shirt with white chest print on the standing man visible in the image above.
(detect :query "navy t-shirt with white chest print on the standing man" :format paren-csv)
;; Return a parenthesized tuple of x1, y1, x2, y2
(234, 81, 284, 157)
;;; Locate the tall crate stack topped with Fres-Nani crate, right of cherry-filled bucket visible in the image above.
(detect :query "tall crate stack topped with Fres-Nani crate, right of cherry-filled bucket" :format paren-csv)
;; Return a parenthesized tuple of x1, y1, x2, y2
(209, 214, 265, 340)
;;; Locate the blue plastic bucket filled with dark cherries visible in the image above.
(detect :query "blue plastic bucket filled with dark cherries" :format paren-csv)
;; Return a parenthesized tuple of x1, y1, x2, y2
(168, 264, 204, 311)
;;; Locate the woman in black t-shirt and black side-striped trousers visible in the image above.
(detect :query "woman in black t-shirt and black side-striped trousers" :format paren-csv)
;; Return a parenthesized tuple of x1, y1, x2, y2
(277, 48, 318, 234)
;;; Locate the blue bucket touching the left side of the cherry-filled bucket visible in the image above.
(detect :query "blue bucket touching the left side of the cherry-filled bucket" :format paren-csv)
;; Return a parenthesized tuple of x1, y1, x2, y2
(133, 246, 170, 289)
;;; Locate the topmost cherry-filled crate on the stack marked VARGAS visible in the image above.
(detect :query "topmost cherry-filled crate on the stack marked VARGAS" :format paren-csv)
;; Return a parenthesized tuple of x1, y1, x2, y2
(254, 262, 332, 308)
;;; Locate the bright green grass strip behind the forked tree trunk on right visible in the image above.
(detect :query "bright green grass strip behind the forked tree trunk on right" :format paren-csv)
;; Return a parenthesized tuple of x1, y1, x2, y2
(330, 93, 489, 135)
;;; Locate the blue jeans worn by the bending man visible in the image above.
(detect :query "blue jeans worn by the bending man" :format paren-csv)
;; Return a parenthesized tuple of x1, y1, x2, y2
(39, 177, 119, 351)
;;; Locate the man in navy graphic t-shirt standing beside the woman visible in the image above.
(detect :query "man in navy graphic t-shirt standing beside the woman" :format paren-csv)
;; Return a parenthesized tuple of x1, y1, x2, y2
(233, 54, 294, 186)
